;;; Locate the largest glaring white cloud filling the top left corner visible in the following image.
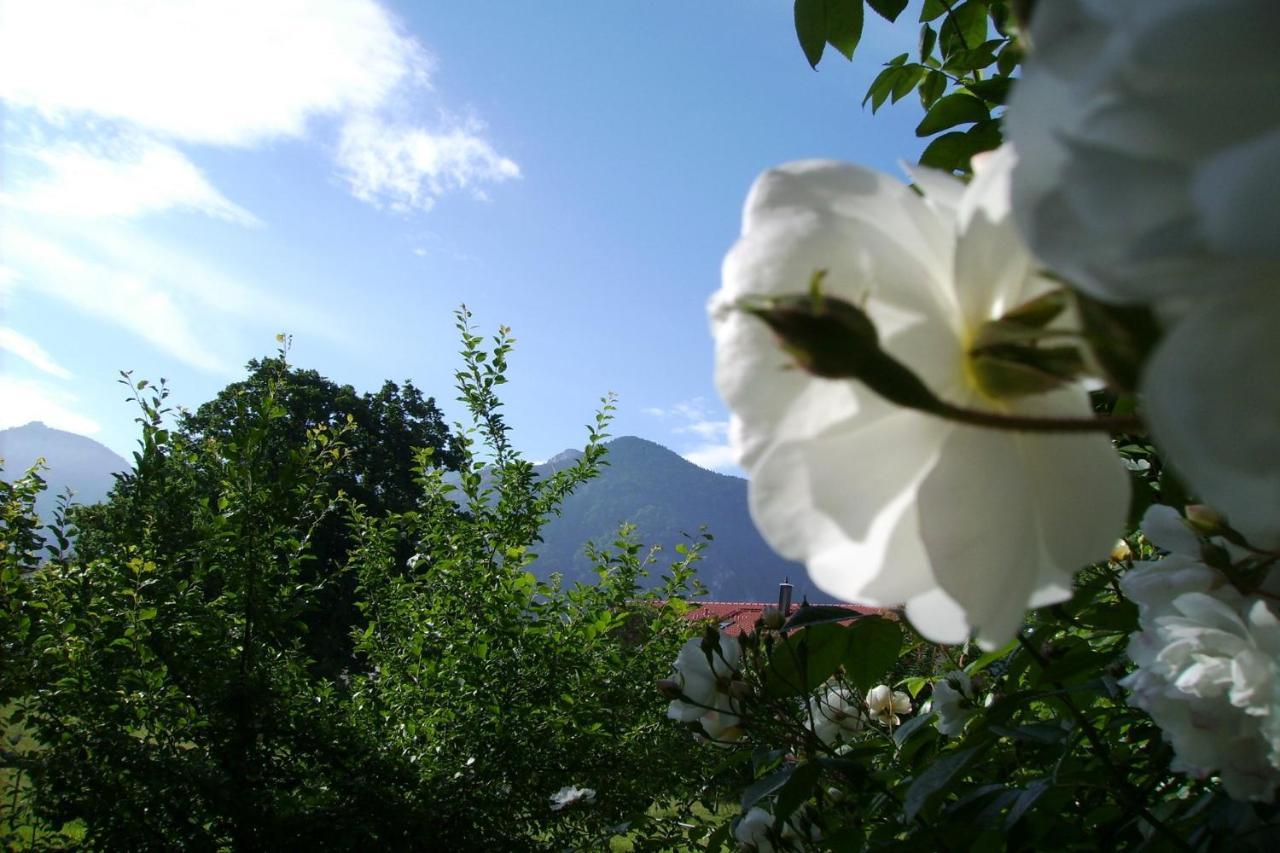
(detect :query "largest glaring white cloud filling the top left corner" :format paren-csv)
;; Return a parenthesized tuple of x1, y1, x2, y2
(0, 0, 430, 146)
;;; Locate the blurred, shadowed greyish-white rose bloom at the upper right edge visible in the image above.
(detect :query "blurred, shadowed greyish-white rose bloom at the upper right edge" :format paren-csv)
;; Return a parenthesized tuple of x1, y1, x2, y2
(1007, 0, 1280, 548)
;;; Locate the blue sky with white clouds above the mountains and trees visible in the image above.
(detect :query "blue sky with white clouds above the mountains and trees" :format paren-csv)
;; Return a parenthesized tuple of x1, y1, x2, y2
(0, 0, 922, 470)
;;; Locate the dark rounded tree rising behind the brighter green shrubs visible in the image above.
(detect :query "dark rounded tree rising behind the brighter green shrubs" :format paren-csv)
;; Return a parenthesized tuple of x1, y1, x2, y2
(73, 338, 461, 676)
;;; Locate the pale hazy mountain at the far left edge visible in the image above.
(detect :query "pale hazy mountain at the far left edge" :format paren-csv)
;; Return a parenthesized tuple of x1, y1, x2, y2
(0, 420, 131, 523)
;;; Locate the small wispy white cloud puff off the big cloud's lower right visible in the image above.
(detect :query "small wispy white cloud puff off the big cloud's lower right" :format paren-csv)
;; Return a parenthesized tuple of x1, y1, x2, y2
(338, 117, 520, 211)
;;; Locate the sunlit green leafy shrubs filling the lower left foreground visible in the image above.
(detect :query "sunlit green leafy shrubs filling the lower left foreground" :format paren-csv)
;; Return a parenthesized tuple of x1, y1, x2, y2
(0, 313, 721, 850)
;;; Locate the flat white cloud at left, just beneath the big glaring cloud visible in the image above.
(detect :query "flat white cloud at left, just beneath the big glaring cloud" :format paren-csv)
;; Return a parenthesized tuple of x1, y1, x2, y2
(6, 134, 261, 225)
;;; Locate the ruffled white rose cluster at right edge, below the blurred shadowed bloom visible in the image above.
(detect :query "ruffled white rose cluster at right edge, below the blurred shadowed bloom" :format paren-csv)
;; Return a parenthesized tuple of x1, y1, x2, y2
(1120, 507, 1280, 800)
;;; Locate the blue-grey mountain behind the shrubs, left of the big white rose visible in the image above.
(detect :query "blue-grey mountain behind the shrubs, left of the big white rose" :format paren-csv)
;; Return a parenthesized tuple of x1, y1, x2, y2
(532, 437, 832, 603)
